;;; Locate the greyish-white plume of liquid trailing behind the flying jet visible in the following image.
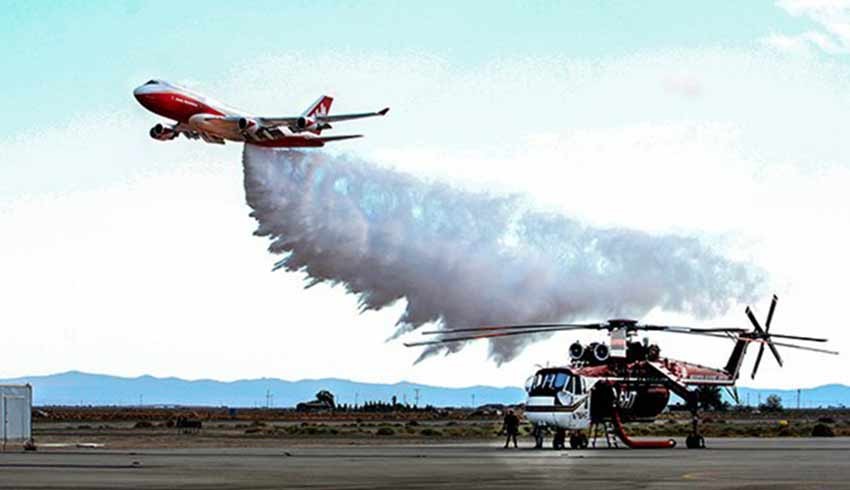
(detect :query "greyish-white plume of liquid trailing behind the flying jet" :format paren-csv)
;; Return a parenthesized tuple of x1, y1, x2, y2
(243, 145, 762, 363)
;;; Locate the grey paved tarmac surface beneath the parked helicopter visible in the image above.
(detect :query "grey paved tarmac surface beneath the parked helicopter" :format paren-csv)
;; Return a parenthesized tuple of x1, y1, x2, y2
(0, 438, 850, 490)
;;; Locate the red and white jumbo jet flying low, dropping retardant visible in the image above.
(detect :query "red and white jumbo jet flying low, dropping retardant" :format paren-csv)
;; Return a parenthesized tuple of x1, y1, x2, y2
(133, 80, 390, 148)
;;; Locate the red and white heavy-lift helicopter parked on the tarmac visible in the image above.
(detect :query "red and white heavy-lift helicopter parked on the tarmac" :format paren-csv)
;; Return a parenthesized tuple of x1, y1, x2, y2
(404, 295, 838, 449)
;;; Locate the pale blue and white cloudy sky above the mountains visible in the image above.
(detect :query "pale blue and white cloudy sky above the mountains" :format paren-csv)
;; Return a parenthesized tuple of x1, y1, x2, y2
(0, 0, 850, 388)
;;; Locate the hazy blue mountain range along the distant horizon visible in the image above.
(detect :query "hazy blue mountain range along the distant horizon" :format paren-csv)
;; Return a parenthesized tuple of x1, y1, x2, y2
(0, 371, 850, 408)
